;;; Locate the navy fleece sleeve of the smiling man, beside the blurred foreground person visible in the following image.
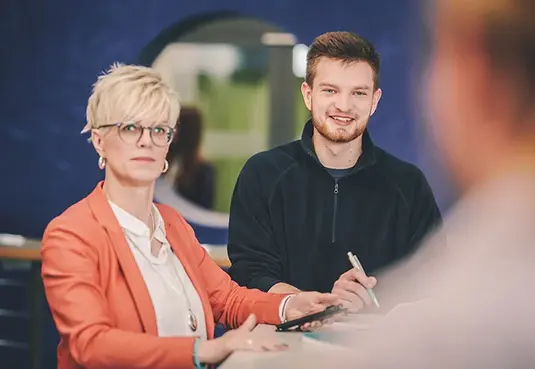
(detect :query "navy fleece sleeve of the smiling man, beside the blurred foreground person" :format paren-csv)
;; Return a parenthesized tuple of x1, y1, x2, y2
(407, 170, 442, 250)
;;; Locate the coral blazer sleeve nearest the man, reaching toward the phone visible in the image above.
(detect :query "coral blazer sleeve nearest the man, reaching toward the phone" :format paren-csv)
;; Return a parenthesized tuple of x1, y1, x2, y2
(175, 215, 286, 328)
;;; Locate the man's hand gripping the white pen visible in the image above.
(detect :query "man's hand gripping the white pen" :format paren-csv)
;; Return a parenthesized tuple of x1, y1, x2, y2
(332, 268, 377, 313)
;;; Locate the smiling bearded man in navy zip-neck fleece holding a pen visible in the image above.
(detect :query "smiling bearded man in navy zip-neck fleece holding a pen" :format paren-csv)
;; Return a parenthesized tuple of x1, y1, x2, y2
(228, 32, 440, 310)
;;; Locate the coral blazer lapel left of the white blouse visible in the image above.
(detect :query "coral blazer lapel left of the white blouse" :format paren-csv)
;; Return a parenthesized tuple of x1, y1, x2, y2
(87, 181, 158, 336)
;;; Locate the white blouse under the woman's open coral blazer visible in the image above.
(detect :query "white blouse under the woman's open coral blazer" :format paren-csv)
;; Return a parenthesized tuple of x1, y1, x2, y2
(110, 201, 207, 339)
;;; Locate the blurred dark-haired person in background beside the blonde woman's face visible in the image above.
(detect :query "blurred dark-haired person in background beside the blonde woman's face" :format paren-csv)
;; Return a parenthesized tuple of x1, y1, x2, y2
(167, 107, 215, 209)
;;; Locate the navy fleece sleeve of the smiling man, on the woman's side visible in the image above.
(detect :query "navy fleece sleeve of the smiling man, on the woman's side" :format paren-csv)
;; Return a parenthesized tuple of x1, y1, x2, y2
(228, 157, 284, 292)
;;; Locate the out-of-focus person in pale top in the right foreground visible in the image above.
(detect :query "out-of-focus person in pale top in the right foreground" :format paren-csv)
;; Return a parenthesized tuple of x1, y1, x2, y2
(316, 0, 535, 369)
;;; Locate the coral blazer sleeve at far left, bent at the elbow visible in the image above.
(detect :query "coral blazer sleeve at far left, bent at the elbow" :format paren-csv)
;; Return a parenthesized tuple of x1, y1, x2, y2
(41, 221, 195, 369)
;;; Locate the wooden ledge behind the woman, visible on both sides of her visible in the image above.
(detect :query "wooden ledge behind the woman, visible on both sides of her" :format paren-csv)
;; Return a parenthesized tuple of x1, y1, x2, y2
(0, 239, 230, 268)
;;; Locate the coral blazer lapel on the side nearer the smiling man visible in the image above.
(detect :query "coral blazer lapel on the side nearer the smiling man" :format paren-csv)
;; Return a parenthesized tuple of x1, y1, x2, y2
(158, 208, 215, 338)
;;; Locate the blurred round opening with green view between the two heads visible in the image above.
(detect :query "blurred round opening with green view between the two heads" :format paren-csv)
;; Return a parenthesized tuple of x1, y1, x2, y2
(141, 14, 308, 213)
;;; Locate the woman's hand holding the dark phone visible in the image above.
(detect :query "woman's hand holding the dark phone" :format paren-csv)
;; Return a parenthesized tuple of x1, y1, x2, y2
(285, 292, 341, 330)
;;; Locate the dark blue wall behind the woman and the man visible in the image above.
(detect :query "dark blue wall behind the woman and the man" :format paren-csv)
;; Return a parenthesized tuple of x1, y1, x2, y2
(0, 0, 448, 237)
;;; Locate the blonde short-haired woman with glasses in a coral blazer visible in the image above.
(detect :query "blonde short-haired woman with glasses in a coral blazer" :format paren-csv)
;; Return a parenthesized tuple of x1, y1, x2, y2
(42, 65, 337, 369)
